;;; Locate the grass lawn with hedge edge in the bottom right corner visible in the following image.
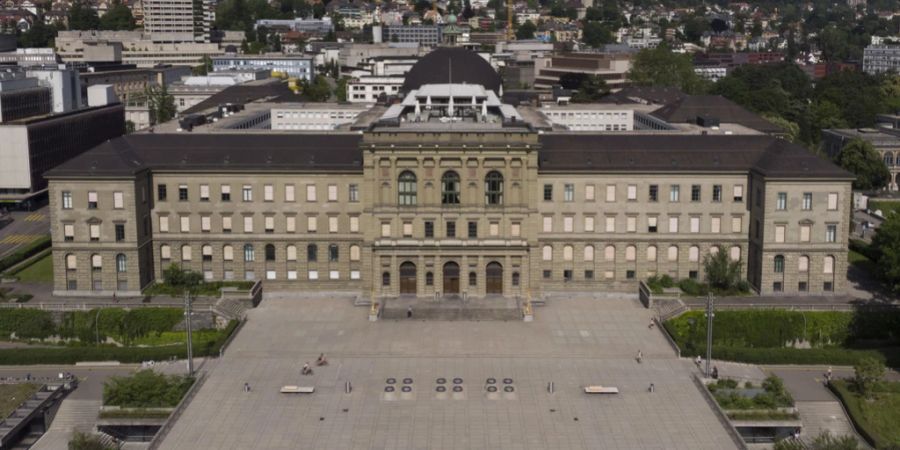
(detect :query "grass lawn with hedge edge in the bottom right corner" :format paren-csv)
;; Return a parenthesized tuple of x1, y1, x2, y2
(832, 380, 900, 448)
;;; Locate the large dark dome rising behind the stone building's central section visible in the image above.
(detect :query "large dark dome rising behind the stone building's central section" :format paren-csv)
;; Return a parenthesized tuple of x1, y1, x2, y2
(403, 47, 502, 93)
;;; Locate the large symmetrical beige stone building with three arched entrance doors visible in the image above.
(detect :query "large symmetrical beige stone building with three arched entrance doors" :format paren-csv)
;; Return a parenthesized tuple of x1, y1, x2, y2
(47, 48, 851, 298)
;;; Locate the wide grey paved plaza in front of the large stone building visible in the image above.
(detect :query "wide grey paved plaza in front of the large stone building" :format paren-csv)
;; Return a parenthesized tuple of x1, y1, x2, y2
(162, 298, 735, 450)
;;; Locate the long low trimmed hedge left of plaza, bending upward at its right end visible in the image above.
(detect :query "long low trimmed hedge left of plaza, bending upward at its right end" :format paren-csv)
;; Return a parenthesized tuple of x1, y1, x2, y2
(0, 321, 237, 366)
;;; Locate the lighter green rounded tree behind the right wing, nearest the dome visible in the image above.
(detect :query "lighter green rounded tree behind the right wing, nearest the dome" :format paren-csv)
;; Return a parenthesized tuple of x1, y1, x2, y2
(628, 45, 703, 94)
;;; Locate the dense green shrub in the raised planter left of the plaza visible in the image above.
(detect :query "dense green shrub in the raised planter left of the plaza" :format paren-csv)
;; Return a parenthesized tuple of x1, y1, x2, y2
(103, 370, 194, 408)
